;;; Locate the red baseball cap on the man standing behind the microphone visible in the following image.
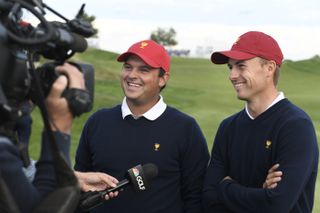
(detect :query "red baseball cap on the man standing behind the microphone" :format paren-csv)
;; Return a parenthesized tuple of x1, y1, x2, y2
(117, 40, 170, 73)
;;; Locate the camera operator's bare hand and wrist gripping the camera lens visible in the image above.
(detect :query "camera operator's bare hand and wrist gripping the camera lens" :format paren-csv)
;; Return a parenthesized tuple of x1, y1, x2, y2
(46, 63, 85, 134)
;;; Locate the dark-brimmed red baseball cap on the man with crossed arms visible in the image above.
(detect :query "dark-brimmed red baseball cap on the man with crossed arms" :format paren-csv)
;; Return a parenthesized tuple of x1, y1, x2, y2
(211, 31, 283, 66)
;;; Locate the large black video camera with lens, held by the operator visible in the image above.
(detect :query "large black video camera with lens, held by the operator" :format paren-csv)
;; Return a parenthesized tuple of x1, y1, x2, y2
(0, 0, 95, 124)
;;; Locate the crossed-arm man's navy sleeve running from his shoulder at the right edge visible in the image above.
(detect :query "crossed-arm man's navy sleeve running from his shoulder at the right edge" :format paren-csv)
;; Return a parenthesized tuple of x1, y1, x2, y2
(206, 119, 318, 213)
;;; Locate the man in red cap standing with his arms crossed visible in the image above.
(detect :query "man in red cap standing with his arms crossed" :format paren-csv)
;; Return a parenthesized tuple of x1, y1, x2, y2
(203, 31, 319, 213)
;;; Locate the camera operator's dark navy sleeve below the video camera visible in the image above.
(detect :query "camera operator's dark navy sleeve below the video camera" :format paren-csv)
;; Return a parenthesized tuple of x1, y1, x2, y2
(0, 132, 70, 213)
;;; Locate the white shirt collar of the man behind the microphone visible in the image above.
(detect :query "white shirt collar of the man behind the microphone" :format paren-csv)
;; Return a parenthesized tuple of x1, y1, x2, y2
(121, 95, 167, 121)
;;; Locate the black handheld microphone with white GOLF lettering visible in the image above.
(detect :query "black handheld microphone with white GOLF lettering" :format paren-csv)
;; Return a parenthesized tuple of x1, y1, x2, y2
(80, 163, 158, 211)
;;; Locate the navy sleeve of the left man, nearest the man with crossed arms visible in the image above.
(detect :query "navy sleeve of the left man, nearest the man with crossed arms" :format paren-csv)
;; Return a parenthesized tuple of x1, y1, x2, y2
(181, 120, 209, 213)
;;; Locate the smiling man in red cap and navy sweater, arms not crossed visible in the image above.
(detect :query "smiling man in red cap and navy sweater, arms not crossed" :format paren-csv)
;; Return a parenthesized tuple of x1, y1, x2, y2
(75, 40, 209, 213)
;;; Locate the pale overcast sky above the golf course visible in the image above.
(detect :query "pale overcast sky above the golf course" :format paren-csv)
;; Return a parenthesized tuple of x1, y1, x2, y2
(43, 0, 320, 60)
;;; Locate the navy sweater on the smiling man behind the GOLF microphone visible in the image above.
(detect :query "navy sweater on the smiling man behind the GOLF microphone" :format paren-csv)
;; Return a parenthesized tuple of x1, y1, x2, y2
(75, 105, 209, 213)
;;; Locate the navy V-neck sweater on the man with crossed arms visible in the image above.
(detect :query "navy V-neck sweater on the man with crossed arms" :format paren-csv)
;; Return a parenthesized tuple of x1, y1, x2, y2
(203, 99, 319, 213)
